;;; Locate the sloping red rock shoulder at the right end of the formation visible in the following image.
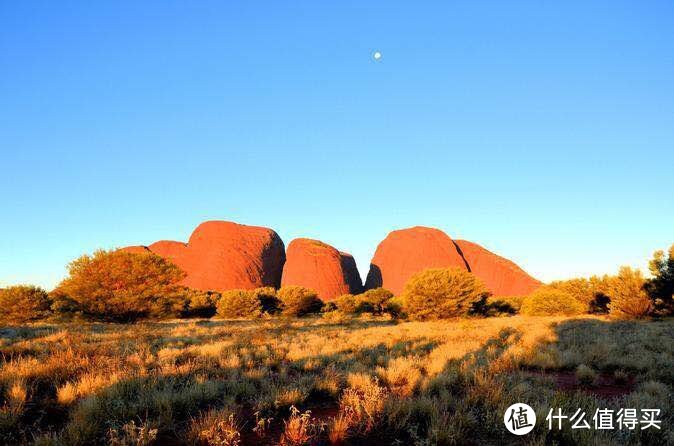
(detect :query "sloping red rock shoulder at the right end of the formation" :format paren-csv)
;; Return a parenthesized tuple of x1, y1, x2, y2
(455, 240, 541, 296)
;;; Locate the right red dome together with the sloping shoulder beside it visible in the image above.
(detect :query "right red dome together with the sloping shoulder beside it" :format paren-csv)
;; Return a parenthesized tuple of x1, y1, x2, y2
(365, 226, 541, 296)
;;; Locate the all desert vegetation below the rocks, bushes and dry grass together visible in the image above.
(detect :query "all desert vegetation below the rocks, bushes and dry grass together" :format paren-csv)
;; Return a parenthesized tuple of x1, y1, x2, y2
(0, 246, 674, 445)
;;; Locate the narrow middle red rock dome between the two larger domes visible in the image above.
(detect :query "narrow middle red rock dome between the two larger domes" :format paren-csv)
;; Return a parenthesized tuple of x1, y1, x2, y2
(281, 238, 362, 301)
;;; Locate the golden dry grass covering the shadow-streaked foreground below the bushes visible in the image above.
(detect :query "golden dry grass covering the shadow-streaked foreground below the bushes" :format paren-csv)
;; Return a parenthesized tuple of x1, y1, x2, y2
(0, 316, 674, 444)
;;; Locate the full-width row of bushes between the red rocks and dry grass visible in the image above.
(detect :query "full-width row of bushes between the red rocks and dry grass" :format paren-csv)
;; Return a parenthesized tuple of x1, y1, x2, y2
(0, 246, 674, 323)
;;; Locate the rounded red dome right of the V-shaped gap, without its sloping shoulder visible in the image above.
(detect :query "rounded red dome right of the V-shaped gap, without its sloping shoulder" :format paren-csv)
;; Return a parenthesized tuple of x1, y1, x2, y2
(365, 226, 468, 294)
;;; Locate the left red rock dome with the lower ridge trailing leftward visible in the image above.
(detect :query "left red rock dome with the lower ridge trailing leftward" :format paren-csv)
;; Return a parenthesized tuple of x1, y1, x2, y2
(123, 221, 285, 291)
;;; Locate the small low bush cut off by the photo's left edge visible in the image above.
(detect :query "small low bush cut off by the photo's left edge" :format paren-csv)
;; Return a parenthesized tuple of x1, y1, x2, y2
(0, 285, 51, 323)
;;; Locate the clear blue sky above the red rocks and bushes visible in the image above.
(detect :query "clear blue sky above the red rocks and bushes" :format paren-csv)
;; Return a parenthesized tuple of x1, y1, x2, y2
(0, 0, 674, 287)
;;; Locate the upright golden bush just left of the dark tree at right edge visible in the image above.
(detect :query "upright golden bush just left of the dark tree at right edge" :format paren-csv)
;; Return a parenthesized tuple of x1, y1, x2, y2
(608, 266, 652, 319)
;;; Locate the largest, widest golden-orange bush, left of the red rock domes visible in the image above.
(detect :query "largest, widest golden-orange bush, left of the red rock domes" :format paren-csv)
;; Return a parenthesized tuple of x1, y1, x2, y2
(55, 250, 184, 320)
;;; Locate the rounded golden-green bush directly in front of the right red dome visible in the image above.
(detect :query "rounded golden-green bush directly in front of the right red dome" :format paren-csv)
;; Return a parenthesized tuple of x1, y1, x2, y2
(402, 268, 487, 320)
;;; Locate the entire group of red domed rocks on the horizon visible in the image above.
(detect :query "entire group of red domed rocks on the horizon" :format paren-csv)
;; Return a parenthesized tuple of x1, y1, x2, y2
(123, 221, 541, 300)
